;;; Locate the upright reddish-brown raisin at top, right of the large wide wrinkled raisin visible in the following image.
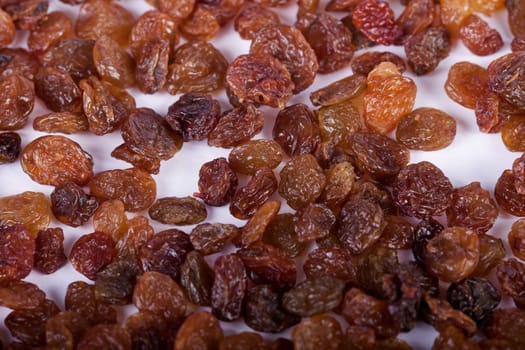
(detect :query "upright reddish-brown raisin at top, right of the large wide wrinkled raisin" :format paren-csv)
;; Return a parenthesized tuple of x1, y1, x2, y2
(303, 13, 354, 74)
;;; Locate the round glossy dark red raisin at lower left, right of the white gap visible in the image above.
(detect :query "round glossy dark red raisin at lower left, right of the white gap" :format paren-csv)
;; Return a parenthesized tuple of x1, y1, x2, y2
(69, 232, 115, 280)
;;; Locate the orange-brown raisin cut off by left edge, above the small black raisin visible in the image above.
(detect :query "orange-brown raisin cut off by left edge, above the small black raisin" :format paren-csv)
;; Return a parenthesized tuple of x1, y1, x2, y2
(0, 74, 35, 130)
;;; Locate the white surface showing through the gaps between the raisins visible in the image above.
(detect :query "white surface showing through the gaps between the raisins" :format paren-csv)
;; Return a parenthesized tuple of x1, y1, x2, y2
(0, 0, 519, 349)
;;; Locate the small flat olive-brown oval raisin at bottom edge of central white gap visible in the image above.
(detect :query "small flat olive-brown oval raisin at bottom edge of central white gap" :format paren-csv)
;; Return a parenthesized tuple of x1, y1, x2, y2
(148, 197, 208, 225)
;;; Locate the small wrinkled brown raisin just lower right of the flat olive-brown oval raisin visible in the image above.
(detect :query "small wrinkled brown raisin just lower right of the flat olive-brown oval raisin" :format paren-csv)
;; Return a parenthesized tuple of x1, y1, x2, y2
(190, 223, 240, 255)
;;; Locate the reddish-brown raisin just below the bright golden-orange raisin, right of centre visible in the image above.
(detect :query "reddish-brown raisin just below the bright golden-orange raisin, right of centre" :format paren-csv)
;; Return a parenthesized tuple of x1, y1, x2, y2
(346, 132, 410, 180)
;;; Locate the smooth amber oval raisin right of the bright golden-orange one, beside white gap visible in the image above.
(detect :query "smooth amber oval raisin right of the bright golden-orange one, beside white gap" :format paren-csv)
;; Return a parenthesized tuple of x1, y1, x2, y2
(396, 107, 456, 151)
